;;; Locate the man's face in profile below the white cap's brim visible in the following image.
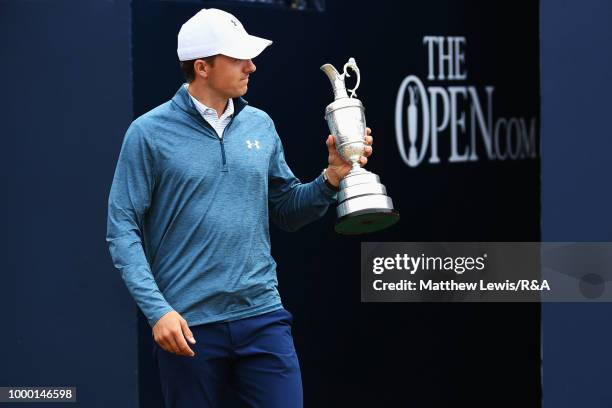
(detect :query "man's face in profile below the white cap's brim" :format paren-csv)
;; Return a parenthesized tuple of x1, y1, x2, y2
(207, 55, 255, 98)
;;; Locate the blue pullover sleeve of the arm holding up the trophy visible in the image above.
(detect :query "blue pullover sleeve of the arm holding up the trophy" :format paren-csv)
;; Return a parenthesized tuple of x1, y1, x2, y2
(268, 120, 336, 231)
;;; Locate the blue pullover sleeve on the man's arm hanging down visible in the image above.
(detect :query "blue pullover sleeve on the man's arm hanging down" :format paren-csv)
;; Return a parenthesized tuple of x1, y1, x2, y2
(106, 123, 173, 327)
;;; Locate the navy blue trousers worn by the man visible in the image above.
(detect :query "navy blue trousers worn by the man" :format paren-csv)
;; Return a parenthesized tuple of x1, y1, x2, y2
(153, 309, 303, 408)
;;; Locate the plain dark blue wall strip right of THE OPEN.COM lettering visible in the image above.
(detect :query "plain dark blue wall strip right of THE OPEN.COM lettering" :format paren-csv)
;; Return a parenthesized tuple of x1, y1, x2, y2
(541, 0, 612, 408)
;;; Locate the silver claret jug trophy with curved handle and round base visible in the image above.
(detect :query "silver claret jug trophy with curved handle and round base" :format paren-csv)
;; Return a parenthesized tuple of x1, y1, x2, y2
(321, 58, 399, 235)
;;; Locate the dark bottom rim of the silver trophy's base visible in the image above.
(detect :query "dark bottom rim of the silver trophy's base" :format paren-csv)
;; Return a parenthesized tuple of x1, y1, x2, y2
(334, 208, 399, 235)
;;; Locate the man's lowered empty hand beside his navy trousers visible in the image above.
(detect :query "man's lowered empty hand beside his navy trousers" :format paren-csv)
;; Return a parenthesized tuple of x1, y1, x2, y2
(153, 310, 195, 357)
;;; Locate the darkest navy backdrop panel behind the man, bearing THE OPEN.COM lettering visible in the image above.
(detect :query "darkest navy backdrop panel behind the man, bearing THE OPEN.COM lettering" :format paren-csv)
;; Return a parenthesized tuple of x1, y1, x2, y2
(133, 0, 540, 407)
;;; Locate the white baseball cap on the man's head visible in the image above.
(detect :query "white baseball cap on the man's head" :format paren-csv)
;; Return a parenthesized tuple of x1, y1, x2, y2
(176, 9, 272, 61)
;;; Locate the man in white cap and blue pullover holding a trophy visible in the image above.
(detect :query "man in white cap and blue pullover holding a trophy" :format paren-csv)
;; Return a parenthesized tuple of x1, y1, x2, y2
(107, 9, 372, 408)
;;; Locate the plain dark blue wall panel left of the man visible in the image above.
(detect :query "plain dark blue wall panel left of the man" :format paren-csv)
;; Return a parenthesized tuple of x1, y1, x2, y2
(0, 0, 137, 408)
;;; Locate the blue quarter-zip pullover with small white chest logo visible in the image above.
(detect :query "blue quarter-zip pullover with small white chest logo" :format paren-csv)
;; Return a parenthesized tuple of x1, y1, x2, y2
(106, 86, 335, 326)
